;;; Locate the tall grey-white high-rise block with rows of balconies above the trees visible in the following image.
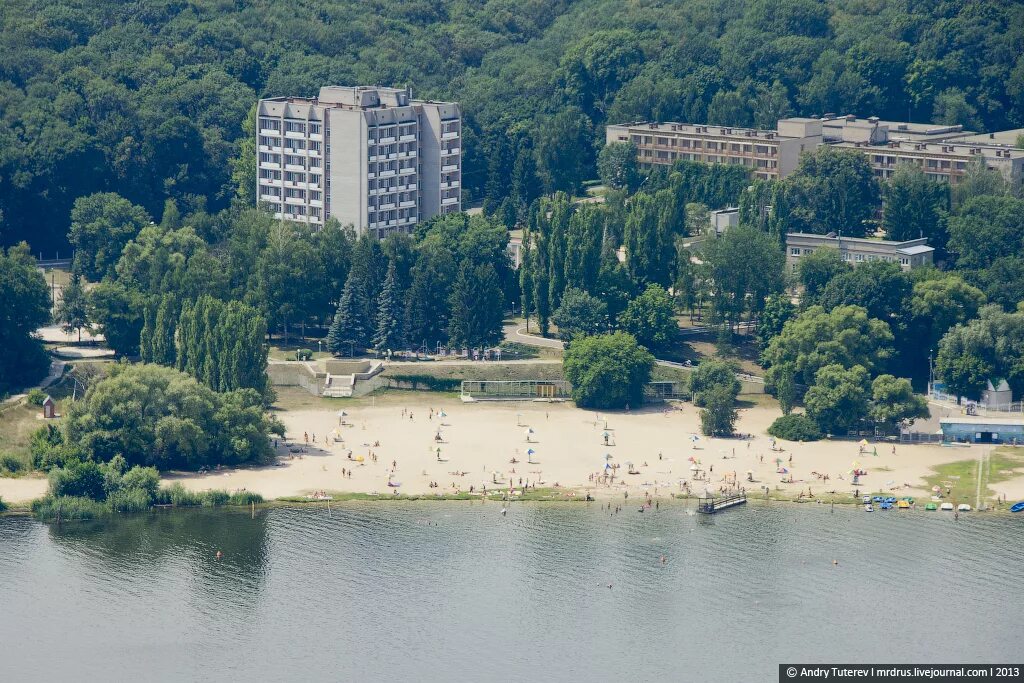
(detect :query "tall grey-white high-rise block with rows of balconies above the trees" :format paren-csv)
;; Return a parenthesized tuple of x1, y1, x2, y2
(256, 86, 462, 238)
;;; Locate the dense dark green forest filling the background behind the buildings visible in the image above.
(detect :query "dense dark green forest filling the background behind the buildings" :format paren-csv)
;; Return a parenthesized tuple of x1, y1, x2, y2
(0, 0, 1024, 252)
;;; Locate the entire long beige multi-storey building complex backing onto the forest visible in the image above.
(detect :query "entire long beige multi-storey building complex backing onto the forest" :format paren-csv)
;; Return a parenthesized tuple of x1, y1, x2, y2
(606, 115, 1024, 183)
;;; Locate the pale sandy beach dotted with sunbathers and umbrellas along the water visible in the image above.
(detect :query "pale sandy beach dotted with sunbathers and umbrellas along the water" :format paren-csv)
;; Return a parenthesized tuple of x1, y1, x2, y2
(0, 394, 1024, 504)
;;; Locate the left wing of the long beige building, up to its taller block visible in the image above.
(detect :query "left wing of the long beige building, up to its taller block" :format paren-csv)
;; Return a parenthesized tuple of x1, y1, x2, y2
(605, 119, 821, 178)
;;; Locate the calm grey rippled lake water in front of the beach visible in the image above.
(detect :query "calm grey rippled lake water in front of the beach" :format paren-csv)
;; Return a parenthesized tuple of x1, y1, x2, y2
(0, 503, 1024, 681)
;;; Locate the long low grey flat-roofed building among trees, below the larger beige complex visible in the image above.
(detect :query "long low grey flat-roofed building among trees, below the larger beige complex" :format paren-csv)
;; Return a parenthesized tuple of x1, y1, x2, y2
(785, 232, 935, 270)
